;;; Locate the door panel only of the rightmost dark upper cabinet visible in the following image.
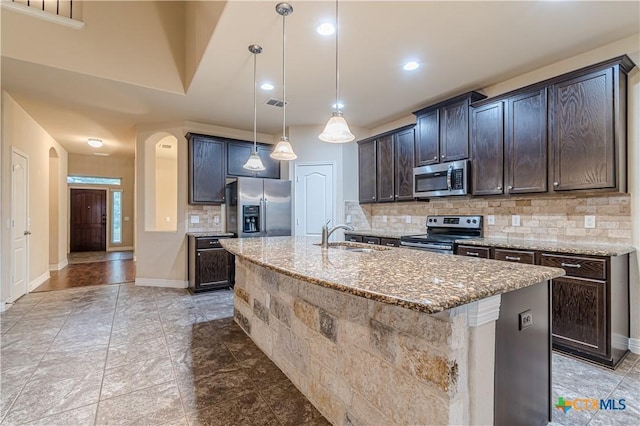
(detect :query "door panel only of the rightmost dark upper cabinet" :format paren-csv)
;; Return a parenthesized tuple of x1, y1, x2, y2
(550, 68, 616, 191)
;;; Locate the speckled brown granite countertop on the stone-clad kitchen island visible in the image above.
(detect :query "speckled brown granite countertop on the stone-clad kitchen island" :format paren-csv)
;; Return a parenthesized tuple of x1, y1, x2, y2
(220, 237, 564, 314)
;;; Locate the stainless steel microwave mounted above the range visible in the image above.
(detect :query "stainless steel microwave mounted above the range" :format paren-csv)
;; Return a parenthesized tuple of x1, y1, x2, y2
(413, 160, 469, 198)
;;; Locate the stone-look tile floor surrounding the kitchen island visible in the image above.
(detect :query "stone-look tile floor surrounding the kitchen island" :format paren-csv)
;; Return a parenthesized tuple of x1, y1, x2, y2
(0, 284, 640, 426)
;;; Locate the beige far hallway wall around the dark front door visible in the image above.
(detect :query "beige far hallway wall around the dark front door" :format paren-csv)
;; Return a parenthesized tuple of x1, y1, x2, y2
(64, 154, 135, 250)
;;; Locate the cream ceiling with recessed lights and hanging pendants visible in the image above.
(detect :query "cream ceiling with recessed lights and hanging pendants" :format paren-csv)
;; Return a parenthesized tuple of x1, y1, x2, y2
(1, 1, 640, 155)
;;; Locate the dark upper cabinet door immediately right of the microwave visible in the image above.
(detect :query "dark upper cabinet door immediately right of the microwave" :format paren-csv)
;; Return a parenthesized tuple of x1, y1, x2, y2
(471, 102, 504, 195)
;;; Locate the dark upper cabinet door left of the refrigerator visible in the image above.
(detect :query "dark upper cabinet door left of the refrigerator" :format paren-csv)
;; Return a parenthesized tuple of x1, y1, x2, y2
(189, 136, 226, 204)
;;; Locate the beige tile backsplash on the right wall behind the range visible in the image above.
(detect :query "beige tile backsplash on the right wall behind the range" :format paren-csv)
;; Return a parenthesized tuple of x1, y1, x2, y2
(345, 194, 632, 245)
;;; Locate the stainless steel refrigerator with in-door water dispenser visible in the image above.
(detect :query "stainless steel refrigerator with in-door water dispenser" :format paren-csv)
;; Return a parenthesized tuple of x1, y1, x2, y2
(226, 177, 291, 238)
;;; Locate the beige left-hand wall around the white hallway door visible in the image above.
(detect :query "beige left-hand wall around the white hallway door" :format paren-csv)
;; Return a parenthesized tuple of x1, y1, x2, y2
(0, 91, 67, 301)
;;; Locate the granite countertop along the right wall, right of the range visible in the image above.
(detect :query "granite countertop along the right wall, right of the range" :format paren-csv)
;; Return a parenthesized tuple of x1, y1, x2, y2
(456, 238, 636, 256)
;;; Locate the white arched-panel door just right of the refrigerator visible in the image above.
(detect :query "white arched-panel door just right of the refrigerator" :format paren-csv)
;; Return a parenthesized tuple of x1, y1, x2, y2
(295, 163, 336, 236)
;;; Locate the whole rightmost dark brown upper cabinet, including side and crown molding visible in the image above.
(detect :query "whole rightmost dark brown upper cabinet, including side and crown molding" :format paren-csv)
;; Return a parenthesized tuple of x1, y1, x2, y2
(549, 56, 634, 192)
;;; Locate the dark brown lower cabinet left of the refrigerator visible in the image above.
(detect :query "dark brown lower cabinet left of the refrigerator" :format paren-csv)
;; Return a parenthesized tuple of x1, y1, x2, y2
(189, 235, 234, 293)
